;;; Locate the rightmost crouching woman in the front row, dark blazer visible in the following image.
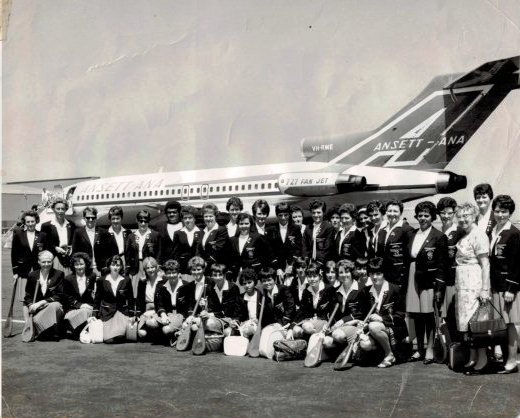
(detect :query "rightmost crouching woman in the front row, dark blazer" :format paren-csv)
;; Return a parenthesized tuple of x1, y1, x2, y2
(360, 257, 408, 368)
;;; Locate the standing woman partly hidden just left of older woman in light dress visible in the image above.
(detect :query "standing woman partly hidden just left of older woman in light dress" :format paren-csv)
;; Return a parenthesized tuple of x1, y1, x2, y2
(437, 197, 463, 339)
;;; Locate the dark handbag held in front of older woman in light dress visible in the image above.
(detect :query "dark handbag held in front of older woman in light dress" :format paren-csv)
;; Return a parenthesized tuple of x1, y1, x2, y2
(468, 301, 507, 348)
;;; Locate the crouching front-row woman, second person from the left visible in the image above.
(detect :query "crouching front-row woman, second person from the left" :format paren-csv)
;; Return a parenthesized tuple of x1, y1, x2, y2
(63, 252, 96, 339)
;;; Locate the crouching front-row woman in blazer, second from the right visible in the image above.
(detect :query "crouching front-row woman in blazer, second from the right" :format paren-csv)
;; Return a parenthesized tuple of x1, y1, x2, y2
(324, 260, 366, 348)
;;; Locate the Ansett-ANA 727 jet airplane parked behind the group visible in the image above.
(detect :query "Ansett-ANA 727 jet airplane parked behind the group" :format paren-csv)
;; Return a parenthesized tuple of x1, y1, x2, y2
(42, 56, 520, 227)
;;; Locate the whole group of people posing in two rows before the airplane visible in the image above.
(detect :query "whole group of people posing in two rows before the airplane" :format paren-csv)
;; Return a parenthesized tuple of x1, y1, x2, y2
(12, 184, 520, 374)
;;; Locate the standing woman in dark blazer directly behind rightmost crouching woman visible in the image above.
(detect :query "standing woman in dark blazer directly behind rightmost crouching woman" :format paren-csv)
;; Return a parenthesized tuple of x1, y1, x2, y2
(377, 200, 413, 295)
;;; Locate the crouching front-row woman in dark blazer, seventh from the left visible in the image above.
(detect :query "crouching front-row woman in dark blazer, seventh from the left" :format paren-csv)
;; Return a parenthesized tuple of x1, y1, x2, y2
(204, 262, 240, 342)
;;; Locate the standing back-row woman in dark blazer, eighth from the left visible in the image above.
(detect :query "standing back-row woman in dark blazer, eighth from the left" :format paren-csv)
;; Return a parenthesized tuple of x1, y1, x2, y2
(197, 203, 229, 271)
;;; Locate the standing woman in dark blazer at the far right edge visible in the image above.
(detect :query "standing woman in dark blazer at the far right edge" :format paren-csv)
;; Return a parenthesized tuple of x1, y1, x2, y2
(489, 195, 520, 374)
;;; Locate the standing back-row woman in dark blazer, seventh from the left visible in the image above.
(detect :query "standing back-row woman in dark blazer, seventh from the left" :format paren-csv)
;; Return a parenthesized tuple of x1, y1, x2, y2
(173, 206, 202, 275)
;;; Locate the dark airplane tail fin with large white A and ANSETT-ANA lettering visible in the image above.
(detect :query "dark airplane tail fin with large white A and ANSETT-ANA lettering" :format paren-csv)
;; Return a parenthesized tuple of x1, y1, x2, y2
(302, 56, 520, 170)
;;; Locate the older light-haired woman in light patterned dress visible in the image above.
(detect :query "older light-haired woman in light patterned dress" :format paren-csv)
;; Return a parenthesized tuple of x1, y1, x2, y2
(455, 203, 490, 374)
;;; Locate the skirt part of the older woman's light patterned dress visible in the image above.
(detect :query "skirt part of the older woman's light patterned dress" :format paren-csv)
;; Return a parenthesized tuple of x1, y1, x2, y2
(455, 264, 482, 332)
